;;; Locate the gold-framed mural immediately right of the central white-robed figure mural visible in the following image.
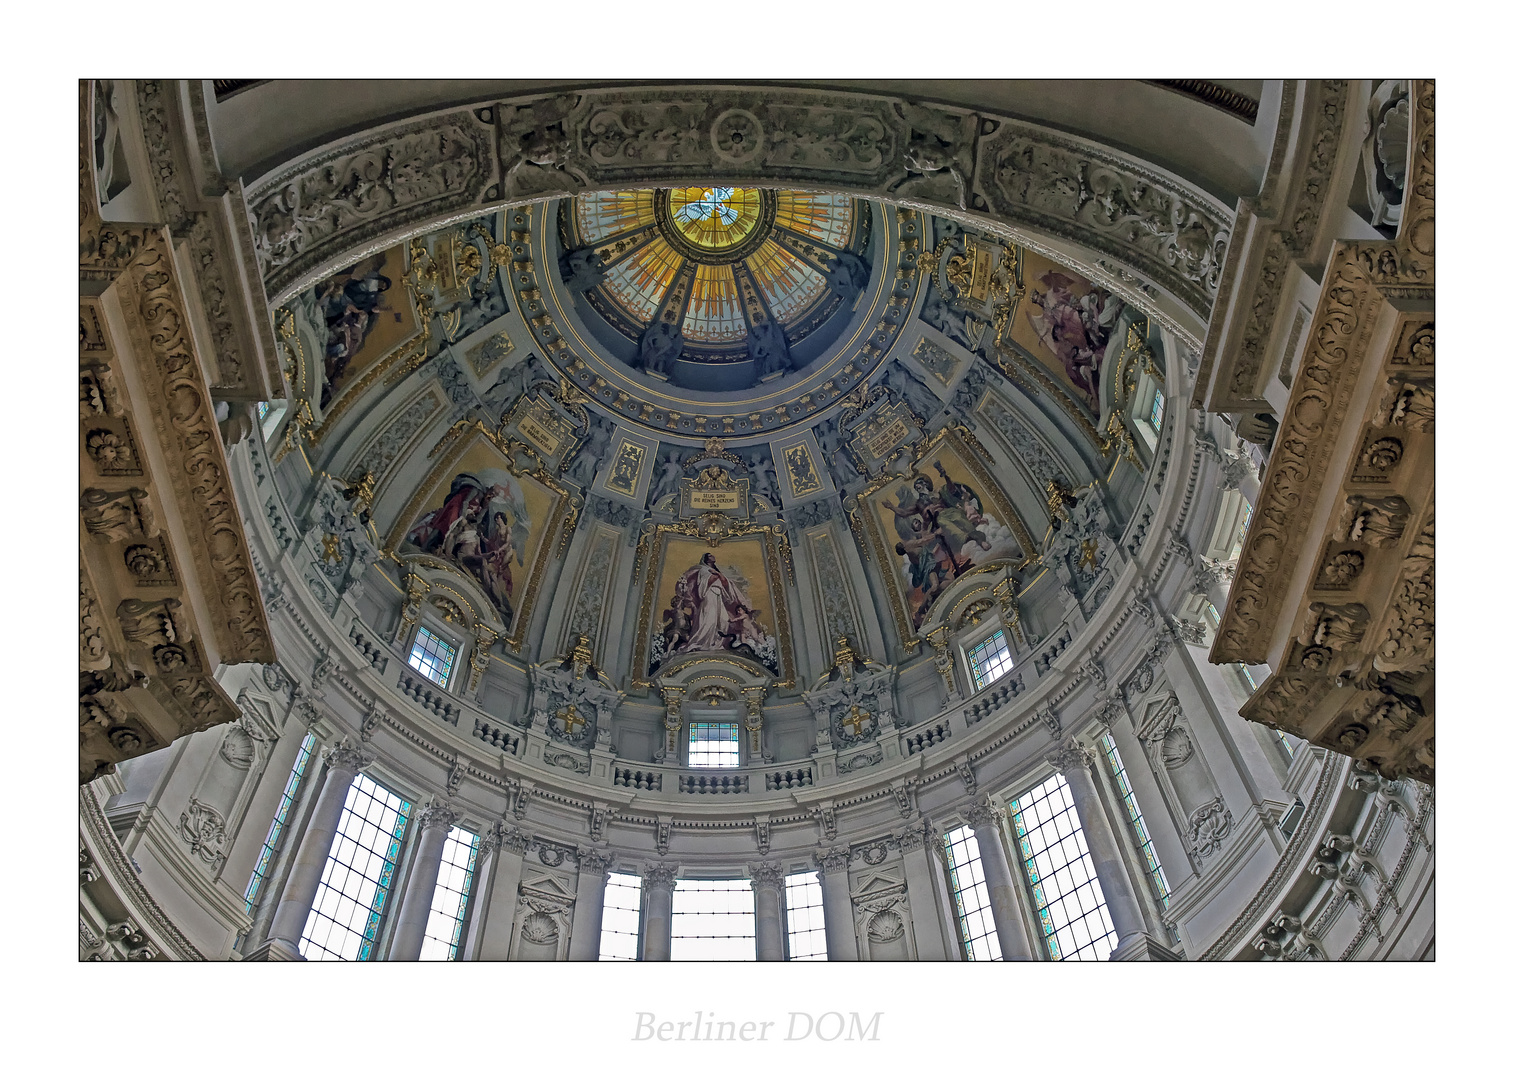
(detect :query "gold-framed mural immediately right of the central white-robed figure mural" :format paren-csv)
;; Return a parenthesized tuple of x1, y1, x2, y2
(860, 432, 1033, 638)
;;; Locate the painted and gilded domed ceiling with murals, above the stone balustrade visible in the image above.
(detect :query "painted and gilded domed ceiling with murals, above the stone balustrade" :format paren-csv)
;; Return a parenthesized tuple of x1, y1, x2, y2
(266, 186, 1166, 760)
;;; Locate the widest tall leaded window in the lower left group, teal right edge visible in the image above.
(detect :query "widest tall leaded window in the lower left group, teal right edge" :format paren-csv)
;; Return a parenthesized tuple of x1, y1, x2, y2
(300, 774, 412, 960)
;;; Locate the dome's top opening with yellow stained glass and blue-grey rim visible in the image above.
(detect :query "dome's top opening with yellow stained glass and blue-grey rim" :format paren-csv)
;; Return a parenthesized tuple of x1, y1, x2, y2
(559, 188, 872, 391)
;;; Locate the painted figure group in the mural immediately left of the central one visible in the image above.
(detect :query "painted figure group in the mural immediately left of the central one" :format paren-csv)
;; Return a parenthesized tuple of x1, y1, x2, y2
(404, 470, 531, 623)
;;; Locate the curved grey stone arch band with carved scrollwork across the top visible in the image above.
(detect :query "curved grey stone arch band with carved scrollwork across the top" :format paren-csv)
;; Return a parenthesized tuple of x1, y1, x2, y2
(247, 86, 1234, 320)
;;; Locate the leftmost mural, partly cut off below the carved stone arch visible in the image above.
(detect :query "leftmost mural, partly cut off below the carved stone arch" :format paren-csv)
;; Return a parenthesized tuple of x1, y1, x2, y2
(297, 245, 419, 410)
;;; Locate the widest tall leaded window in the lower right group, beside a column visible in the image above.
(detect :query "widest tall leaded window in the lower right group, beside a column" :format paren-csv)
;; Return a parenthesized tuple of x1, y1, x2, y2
(1010, 774, 1119, 960)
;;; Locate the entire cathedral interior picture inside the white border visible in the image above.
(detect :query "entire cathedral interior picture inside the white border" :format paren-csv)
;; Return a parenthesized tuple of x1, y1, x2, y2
(79, 80, 1434, 959)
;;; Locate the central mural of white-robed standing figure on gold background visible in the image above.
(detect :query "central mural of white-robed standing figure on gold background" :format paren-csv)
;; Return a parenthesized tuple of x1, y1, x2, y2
(646, 536, 783, 679)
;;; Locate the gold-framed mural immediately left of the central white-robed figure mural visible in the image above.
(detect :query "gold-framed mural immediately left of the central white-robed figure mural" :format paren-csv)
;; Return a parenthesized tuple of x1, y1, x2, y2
(391, 432, 563, 633)
